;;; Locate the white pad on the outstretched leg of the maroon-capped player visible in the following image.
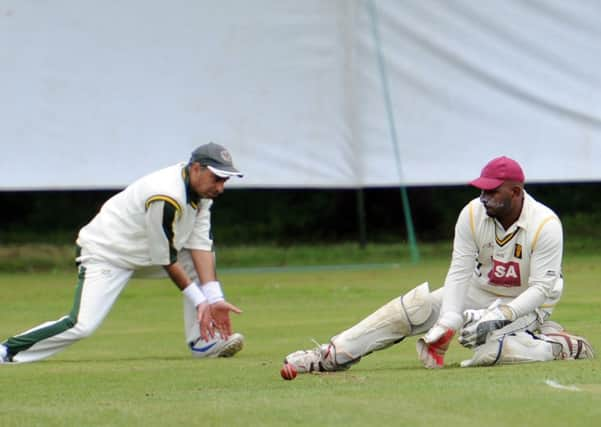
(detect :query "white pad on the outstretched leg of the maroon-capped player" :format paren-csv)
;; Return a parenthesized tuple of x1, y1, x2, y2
(331, 282, 432, 365)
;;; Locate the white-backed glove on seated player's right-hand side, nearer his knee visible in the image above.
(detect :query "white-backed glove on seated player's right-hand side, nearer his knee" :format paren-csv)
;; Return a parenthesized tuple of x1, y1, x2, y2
(459, 305, 515, 348)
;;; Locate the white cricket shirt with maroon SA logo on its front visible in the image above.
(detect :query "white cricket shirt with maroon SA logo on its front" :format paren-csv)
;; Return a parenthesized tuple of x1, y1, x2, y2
(441, 192, 563, 329)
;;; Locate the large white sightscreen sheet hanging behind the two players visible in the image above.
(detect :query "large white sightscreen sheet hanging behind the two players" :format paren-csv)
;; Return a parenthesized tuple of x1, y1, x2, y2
(0, 0, 601, 190)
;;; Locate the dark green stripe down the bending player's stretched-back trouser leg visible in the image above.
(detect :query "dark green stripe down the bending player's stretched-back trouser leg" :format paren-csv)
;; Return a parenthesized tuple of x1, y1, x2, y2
(4, 267, 86, 358)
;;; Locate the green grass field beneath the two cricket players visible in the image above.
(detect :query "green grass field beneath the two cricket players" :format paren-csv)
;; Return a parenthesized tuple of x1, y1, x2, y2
(0, 255, 601, 427)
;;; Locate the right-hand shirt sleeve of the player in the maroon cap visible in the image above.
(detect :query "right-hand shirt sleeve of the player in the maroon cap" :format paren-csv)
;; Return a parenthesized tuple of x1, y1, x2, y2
(508, 216, 563, 317)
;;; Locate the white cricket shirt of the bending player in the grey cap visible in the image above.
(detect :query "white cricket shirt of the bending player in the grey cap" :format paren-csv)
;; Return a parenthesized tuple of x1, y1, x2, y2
(77, 163, 213, 269)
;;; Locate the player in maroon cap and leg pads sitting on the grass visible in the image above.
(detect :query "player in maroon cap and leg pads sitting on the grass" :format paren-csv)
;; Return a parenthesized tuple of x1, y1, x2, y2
(284, 157, 594, 373)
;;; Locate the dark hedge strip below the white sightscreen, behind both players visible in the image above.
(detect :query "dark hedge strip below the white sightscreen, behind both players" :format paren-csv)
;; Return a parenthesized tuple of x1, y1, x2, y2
(0, 183, 601, 246)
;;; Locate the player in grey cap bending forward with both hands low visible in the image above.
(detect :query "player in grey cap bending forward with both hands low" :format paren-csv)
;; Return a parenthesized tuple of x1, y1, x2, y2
(0, 143, 244, 363)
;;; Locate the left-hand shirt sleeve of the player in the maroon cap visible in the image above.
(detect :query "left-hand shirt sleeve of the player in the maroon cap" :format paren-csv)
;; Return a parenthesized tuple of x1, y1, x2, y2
(439, 202, 478, 329)
